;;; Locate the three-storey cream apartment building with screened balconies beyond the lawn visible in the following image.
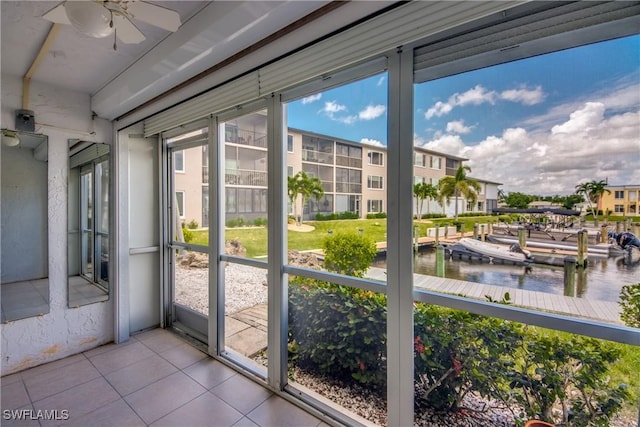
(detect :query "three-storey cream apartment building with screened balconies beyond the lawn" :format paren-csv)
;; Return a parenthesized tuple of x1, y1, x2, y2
(173, 122, 501, 227)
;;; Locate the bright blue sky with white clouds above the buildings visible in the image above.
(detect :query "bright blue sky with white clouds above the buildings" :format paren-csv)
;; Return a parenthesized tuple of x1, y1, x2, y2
(287, 36, 640, 195)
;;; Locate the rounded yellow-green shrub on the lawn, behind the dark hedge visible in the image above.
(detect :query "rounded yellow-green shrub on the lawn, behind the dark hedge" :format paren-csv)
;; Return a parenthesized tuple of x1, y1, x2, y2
(322, 233, 378, 277)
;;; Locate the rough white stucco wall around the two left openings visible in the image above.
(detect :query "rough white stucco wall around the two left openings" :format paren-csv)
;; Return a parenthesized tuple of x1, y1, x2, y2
(0, 74, 114, 375)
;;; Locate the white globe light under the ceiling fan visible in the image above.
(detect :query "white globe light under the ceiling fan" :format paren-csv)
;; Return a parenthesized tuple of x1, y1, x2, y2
(64, 1, 113, 38)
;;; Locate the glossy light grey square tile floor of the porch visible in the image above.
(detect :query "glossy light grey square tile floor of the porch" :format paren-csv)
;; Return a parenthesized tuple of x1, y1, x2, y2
(0, 329, 327, 427)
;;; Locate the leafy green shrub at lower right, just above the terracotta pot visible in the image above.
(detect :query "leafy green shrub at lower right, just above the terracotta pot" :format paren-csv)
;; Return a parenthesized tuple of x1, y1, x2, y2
(506, 333, 630, 427)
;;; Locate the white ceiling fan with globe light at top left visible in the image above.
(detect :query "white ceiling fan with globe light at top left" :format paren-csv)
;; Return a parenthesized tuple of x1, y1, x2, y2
(42, 0, 181, 50)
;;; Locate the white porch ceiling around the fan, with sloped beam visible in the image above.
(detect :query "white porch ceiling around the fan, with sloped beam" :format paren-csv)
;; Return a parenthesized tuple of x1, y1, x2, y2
(0, 0, 370, 119)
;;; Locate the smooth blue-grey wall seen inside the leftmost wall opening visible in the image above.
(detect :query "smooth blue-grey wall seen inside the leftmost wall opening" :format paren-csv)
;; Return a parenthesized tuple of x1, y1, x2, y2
(0, 145, 49, 283)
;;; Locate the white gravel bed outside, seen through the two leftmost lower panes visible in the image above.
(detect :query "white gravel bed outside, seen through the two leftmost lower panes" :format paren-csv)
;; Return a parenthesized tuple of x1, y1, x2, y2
(175, 263, 267, 314)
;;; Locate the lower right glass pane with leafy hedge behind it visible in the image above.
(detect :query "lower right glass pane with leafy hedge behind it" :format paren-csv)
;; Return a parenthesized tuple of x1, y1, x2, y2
(414, 302, 640, 426)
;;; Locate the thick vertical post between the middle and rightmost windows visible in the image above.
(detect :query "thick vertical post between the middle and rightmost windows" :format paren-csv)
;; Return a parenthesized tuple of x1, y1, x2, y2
(387, 50, 414, 426)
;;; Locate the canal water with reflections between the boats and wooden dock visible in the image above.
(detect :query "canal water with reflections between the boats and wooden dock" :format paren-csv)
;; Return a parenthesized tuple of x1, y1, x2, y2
(375, 249, 640, 302)
